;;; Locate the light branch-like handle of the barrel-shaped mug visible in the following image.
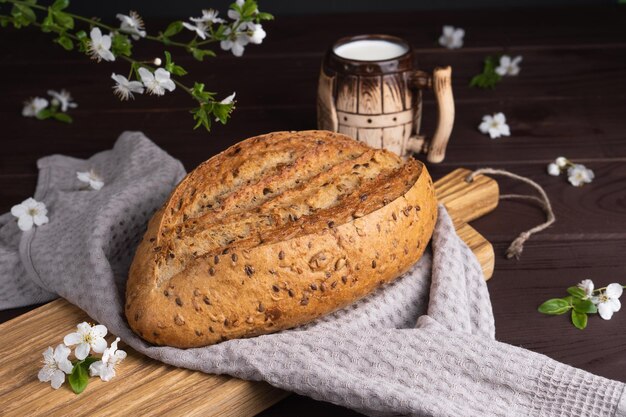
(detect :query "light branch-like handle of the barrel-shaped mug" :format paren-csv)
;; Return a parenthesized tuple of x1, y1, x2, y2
(408, 66, 454, 163)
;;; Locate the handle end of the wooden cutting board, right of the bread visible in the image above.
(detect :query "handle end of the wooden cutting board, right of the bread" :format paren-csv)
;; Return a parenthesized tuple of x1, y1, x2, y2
(435, 168, 500, 280)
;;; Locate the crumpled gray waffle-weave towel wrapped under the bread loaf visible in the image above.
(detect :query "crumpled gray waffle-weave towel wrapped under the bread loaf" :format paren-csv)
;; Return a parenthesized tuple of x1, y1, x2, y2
(0, 132, 626, 417)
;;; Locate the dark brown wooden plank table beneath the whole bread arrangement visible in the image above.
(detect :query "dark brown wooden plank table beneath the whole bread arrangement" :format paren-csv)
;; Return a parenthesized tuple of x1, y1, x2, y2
(0, 6, 626, 416)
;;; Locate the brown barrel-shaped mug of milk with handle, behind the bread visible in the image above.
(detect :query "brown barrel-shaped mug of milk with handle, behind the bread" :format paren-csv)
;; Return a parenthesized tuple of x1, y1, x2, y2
(317, 35, 454, 162)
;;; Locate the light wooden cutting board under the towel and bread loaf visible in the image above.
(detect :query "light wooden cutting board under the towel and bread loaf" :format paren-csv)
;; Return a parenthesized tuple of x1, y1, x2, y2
(0, 169, 499, 416)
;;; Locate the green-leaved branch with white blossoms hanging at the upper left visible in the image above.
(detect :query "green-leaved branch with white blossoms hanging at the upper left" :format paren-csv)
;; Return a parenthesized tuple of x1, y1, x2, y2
(0, 0, 273, 130)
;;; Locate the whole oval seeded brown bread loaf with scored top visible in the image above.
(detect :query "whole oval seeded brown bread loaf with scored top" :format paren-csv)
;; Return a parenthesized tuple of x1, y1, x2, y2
(126, 131, 437, 348)
